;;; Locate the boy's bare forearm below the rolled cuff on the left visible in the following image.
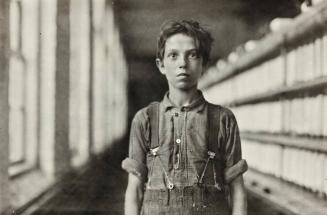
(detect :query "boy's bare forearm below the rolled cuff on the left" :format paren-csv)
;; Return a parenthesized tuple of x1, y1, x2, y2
(125, 173, 143, 215)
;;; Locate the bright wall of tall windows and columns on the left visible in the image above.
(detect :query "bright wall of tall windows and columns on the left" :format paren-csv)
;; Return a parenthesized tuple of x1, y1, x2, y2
(0, 0, 128, 213)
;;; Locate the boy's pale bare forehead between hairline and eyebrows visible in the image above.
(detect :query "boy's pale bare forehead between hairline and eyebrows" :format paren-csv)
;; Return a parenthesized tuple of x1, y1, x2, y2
(165, 33, 198, 50)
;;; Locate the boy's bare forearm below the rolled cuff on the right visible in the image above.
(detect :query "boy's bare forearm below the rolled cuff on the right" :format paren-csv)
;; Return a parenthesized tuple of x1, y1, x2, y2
(230, 175, 247, 215)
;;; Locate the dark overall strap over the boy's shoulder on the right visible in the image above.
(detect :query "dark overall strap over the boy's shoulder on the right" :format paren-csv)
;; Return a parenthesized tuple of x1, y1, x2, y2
(207, 103, 221, 153)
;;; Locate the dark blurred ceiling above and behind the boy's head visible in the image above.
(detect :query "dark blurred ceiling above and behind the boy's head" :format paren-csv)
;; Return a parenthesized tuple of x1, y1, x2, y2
(114, 0, 300, 61)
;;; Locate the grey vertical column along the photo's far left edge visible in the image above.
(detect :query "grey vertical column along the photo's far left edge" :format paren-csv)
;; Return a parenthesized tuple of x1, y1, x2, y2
(0, 0, 10, 213)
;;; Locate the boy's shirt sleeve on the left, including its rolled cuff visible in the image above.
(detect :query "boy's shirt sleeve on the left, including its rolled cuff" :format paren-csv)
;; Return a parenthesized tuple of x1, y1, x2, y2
(122, 109, 149, 181)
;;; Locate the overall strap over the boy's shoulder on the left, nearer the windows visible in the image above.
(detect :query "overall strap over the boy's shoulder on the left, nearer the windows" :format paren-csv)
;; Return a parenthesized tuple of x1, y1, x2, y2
(148, 102, 160, 149)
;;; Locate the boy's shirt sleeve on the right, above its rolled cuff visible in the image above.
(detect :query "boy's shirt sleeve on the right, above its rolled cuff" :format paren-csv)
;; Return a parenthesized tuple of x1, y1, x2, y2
(224, 110, 242, 168)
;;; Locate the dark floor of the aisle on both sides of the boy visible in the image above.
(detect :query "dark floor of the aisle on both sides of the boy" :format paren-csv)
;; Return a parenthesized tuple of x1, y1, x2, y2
(33, 141, 292, 215)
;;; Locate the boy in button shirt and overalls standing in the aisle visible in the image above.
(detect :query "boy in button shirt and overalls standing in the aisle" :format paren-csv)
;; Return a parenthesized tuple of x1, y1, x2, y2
(122, 20, 247, 215)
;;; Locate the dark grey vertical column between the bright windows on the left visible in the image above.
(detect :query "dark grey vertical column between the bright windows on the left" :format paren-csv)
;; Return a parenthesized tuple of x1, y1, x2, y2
(54, 0, 70, 177)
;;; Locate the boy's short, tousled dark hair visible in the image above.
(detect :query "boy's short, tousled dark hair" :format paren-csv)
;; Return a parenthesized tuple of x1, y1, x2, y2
(157, 20, 213, 65)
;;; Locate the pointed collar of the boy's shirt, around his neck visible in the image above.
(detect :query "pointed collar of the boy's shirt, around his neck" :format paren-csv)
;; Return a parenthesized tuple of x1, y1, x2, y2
(161, 90, 206, 112)
